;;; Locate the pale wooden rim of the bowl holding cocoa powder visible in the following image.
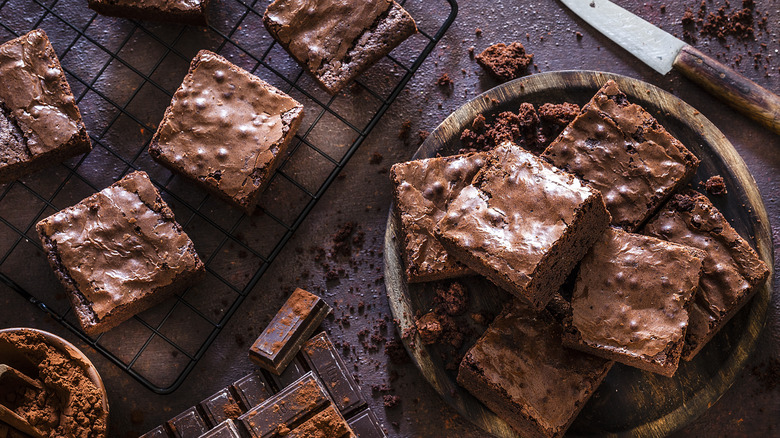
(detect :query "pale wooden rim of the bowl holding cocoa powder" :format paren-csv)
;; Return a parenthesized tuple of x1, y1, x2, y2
(0, 328, 108, 436)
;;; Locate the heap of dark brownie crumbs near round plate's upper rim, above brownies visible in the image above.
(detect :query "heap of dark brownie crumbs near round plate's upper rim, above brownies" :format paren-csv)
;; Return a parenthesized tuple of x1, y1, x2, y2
(460, 102, 580, 154)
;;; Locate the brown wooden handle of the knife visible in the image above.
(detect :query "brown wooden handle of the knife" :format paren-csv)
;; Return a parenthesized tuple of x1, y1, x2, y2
(674, 46, 780, 134)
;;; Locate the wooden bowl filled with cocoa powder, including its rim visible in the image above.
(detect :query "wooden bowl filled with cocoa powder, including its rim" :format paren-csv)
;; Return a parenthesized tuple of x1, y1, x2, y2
(0, 328, 108, 438)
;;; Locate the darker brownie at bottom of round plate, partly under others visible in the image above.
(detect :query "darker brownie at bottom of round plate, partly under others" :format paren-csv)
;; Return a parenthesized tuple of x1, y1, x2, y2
(458, 300, 613, 438)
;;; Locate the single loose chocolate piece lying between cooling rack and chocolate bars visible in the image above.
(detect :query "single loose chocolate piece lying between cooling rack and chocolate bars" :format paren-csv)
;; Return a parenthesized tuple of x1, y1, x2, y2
(249, 288, 331, 376)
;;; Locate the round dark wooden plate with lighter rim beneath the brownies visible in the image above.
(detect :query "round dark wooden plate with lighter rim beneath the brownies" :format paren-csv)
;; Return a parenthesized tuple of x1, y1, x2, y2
(384, 71, 773, 437)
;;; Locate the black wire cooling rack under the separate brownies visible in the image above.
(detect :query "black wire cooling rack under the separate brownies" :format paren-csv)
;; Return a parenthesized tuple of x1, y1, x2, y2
(0, 0, 457, 394)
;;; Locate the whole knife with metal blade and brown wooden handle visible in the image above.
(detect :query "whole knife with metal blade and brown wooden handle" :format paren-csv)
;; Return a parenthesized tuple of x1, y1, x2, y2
(560, 0, 780, 134)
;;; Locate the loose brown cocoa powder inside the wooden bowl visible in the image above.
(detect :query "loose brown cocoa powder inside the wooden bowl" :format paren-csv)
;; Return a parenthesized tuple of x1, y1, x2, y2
(0, 331, 106, 438)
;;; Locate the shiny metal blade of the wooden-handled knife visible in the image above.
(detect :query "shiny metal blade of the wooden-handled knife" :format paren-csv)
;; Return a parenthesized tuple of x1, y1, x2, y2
(561, 0, 688, 75)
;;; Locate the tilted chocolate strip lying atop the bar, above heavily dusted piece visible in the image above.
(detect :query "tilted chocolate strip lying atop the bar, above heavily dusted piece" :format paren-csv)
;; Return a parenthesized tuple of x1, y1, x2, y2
(238, 372, 330, 438)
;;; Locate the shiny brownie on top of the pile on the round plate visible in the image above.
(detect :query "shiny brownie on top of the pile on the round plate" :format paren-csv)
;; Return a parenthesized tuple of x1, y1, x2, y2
(435, 142, 610, 310)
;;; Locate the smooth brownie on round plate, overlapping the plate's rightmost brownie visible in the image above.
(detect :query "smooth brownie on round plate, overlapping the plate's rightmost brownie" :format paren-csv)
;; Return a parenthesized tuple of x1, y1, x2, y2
(563, 228, 706, 377)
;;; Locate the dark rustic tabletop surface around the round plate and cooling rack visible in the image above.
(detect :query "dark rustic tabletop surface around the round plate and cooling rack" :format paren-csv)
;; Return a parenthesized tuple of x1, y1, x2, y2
(0, 0, 780, 437)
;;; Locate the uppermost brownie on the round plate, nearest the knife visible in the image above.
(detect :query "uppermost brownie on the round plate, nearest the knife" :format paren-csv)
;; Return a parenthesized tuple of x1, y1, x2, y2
(542, 80, 699, 232)
